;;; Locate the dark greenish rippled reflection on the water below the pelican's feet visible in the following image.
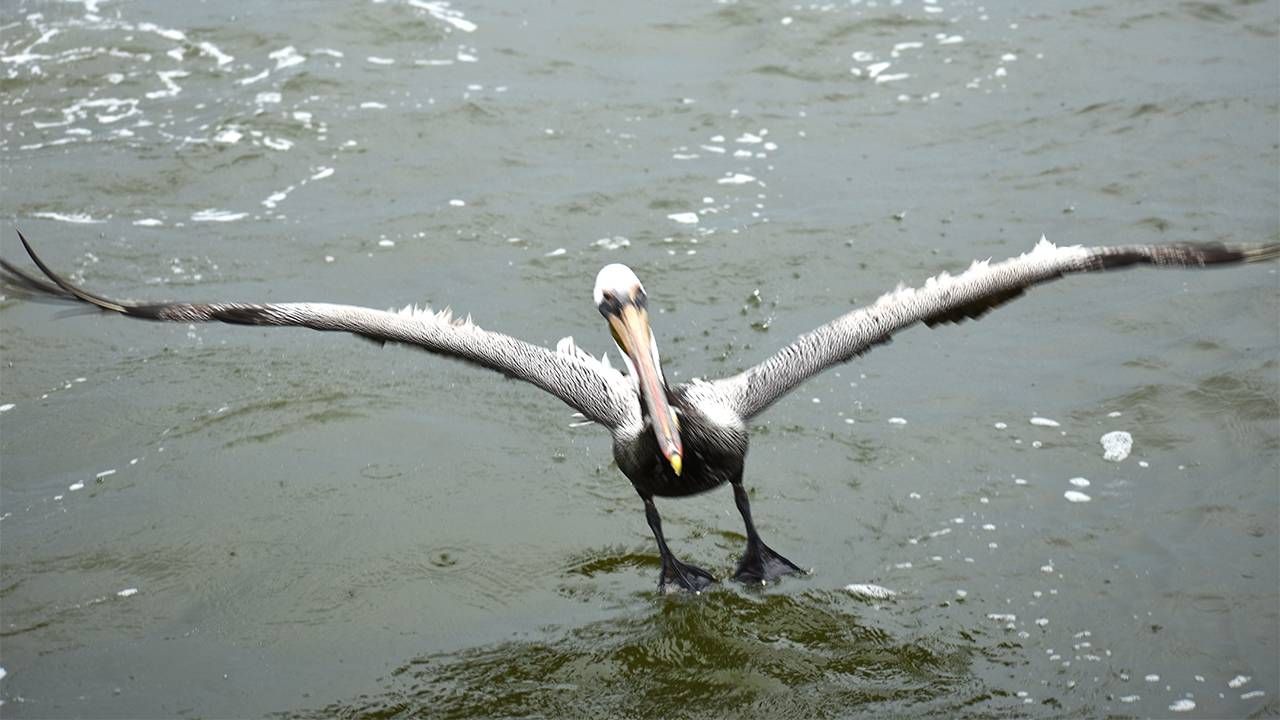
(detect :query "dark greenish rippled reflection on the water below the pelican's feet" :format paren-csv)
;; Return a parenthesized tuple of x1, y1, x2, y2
(279, 566, 1052, 719)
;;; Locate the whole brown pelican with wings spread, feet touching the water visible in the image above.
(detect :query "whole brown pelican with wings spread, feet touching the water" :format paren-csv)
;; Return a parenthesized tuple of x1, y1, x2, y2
(0, 233, 1280, 592)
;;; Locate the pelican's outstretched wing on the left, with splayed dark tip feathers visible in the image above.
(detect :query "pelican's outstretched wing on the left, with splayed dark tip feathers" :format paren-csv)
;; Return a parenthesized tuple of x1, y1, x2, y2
(0, 233, 640, 428)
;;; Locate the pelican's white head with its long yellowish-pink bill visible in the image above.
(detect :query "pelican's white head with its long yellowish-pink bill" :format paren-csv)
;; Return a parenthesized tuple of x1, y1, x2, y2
(594, 264, 684, 475)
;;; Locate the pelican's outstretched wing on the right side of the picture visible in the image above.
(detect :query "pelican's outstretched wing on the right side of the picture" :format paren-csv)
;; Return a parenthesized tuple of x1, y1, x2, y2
(713, 238, 1280, 418)
